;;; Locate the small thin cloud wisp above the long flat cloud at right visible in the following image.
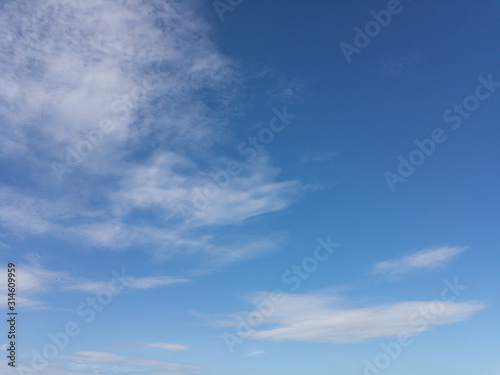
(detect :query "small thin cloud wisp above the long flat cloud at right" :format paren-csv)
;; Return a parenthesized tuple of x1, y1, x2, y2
(372, 247, 466, 279)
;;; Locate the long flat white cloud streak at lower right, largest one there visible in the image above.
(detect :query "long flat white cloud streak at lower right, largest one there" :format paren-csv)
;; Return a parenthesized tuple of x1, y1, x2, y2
(227, 293, 484, 344)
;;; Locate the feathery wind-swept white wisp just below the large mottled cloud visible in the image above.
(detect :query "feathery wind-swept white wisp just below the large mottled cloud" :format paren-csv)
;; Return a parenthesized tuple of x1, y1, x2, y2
(112, 152, 300, 227)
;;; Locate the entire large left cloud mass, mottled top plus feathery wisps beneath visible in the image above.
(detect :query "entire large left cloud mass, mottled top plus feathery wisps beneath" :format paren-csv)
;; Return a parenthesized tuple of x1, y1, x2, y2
(0, 1, 301, 267)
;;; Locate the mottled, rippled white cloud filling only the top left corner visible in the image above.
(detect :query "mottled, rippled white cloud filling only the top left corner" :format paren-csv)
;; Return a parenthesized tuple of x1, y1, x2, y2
(0, 1, 236, 162)
